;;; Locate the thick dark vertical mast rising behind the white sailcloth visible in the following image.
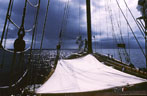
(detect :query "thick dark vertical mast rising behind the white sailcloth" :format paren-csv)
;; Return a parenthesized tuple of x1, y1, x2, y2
(86, 0, 93, 53)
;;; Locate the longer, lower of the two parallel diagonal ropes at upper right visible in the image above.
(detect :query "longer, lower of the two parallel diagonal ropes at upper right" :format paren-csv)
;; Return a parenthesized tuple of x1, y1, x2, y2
(116, 0, 146, 57)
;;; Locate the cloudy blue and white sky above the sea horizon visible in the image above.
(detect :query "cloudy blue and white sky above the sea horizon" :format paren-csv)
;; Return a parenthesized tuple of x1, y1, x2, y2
(0, 0, 144, 49)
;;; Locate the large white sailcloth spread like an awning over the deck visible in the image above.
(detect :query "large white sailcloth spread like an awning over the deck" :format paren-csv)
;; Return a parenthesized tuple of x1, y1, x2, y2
(36, 54, 147, 94)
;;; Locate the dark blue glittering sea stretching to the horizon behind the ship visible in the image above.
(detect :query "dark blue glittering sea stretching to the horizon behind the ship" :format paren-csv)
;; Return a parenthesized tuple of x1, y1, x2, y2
(0, 49, 146, 69)
